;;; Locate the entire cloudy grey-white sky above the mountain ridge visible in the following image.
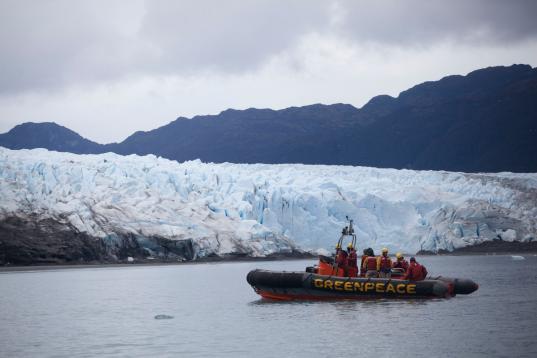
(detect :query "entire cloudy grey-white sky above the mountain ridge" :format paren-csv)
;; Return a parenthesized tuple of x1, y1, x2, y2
(0, 0, 537, 143)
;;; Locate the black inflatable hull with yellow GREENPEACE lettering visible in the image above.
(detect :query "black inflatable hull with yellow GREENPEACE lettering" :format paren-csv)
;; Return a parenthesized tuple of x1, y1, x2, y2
(246, 270, 478, 300)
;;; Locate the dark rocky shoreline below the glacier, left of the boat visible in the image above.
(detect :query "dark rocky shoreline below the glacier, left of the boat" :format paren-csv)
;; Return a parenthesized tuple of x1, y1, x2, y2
(0, 217, 314, 266)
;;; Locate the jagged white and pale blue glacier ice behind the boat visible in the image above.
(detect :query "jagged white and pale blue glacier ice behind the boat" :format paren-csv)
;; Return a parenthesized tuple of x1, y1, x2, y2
(0, 148, 537, 256)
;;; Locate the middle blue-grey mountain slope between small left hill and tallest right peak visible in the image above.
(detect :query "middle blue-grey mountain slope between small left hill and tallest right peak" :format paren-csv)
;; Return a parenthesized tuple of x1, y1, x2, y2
(107, 104, 358, 163)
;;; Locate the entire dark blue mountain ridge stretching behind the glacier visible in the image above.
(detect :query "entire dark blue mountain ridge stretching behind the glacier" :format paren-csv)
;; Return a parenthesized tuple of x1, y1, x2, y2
(0, 65, 537, 172)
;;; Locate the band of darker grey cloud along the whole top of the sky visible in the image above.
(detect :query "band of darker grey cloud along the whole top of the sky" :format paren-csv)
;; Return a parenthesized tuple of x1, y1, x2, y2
(0, 0, 537, 94)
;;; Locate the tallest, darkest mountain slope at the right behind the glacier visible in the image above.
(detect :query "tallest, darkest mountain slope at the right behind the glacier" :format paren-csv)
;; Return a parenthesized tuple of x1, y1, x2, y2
(344, 66, 537, 172)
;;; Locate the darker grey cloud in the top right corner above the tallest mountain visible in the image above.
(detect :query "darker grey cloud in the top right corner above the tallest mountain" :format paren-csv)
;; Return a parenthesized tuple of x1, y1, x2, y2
(338, 0, 537, 46)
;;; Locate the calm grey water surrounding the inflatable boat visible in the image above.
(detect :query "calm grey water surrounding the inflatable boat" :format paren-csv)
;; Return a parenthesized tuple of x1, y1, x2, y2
(0, 255, 537, 357)
